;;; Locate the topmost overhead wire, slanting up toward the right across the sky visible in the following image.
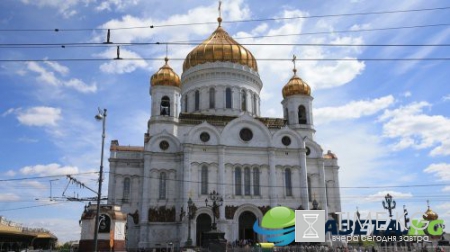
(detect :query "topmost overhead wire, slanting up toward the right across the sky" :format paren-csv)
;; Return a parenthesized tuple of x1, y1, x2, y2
(0, 6, 450, 32)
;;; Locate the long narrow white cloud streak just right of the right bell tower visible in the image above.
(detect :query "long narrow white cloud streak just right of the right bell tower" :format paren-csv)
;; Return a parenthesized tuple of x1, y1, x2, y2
(314, 95, 394, 125)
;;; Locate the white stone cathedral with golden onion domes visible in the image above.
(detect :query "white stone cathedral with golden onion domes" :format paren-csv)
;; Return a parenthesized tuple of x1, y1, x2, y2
(108, 17, 341, 251)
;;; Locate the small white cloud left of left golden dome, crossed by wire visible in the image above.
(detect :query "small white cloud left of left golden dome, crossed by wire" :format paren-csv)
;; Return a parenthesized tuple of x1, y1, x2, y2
(94, 48, 147, 74)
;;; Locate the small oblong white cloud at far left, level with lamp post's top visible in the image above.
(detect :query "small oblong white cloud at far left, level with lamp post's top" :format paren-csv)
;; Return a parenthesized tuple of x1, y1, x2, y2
(17, 107, 61, 126)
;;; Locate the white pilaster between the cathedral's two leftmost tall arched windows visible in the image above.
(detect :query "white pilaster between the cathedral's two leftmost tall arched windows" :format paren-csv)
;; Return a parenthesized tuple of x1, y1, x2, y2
(139, 154, 152, 242)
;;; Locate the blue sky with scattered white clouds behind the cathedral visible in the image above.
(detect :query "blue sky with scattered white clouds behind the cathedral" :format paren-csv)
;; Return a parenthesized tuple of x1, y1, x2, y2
(0, 0, 450, 241)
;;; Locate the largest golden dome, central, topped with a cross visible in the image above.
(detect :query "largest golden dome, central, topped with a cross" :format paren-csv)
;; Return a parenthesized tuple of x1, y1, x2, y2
(183, 18, 258, 72)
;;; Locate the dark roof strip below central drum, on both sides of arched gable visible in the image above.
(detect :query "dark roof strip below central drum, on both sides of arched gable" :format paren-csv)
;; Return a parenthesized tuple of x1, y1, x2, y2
(180, 113, 286, 128)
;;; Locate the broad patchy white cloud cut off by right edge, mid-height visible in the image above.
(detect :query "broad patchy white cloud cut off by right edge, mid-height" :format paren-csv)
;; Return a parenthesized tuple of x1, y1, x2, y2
(380, 102, 450, 156)
